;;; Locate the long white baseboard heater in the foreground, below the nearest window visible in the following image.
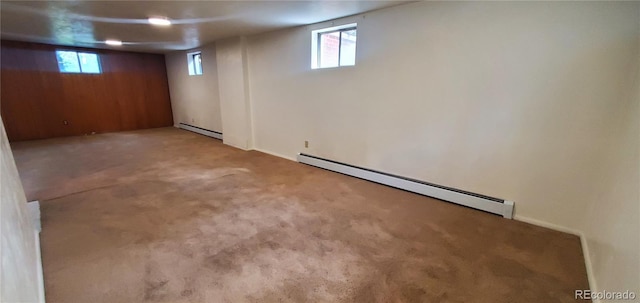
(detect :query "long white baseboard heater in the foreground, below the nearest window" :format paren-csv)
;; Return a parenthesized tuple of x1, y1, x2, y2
(298, 154, 513, 219)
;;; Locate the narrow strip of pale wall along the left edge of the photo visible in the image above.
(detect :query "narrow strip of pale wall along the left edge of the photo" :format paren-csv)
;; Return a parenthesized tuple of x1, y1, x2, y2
(0, 119, 41, 302)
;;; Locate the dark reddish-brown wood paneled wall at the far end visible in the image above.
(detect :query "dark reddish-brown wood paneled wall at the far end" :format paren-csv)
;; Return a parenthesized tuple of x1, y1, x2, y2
(0, 40, 173, 141)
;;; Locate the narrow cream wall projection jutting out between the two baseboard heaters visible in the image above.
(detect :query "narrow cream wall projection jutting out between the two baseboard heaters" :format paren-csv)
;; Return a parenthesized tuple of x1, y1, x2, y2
(216, 37, 253, 150)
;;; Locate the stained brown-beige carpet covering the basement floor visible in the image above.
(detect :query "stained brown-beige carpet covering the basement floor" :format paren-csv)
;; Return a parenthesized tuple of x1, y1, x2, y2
(12, 128, 588, 303)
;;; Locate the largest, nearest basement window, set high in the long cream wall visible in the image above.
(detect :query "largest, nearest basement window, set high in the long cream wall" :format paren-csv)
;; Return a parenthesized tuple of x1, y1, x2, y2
(311, 23, 358, 69)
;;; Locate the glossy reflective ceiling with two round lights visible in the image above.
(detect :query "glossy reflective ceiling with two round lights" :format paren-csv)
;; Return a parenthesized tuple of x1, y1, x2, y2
(0, 0, 408, 52)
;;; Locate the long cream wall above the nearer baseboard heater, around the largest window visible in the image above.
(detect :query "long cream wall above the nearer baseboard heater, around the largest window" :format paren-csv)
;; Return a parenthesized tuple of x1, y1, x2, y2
(246, 2, 640, 231)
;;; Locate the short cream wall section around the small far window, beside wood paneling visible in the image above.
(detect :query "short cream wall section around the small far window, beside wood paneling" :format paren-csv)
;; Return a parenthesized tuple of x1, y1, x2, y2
(165, 43, 222, 132)
